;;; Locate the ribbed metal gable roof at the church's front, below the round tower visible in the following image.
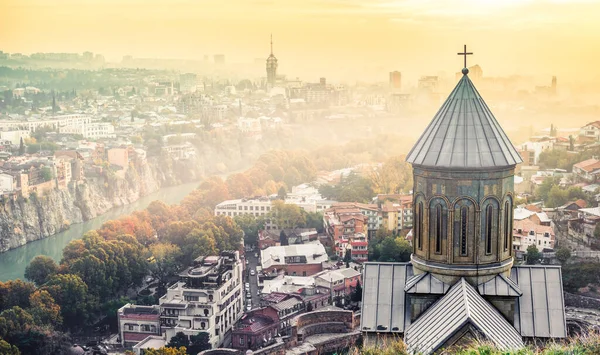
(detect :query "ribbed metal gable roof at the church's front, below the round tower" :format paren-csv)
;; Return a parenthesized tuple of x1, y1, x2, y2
(404, 278, 524, 355)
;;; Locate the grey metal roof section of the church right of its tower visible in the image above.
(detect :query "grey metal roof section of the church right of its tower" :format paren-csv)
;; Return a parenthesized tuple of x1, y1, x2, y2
(510, 265, 567, 338)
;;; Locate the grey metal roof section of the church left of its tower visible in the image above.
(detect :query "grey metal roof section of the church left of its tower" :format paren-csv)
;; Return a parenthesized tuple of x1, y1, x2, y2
(360, 263, 412, 333)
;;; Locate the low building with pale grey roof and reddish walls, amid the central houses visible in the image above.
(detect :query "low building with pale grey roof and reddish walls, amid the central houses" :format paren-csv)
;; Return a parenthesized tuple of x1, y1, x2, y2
(260, 242, 329, 276)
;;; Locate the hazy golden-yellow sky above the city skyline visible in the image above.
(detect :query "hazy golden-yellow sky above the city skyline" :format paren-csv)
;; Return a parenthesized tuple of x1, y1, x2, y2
(0, 0, 600, 80)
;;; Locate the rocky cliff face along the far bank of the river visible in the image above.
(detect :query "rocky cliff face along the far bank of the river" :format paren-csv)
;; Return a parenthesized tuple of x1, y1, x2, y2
(0, 157, 203, 253)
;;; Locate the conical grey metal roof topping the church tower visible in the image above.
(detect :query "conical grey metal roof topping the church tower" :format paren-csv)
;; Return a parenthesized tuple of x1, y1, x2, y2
(406, 75, 522, 169)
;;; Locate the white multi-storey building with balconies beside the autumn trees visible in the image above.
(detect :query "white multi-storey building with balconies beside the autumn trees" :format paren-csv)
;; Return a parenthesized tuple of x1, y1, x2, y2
(159, 251, 244, 348)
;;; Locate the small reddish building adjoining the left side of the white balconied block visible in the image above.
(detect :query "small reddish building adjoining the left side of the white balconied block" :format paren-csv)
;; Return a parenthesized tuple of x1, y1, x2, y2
(117, 303, 164, 347)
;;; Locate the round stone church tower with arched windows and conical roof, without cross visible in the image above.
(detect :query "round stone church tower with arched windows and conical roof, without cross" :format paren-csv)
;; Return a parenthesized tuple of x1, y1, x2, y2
(406, 64, 522, 285)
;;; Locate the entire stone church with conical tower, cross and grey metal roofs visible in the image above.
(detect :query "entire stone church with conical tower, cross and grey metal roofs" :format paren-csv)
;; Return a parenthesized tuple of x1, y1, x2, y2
(360, 46, 567, 355)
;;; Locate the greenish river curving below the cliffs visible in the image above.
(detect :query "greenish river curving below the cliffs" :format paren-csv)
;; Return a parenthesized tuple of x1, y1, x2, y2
(0, 182, 199, 281)
